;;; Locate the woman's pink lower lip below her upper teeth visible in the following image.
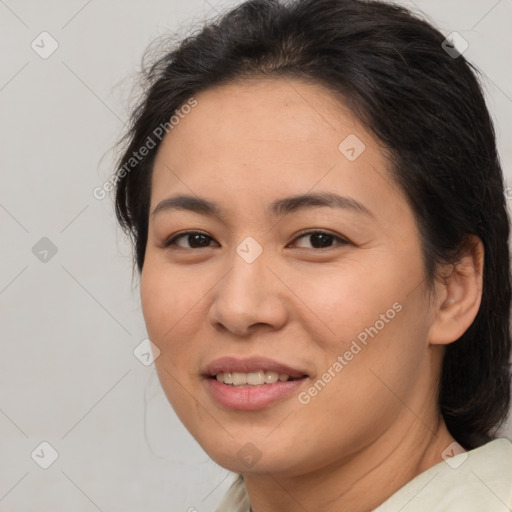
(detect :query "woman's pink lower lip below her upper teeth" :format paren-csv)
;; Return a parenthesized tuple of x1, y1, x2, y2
(205, 378, 307, 411)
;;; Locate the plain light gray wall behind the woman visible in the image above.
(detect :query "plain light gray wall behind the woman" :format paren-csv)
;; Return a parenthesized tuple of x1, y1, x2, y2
(0, 0, 512, 512)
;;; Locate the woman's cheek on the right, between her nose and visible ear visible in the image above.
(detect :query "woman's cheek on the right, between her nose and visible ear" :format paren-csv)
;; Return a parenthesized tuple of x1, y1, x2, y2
(300, 258, 428, 400)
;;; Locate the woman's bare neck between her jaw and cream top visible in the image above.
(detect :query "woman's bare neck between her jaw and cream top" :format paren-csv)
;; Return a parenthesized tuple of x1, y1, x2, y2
(244, 411, 454, 512)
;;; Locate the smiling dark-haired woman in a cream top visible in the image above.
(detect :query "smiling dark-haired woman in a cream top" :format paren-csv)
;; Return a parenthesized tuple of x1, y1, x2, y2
(116, 0, 512, 512)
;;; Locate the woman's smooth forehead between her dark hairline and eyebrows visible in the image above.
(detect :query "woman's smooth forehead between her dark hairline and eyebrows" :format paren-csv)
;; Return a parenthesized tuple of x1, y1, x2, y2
(151, 79, 404, 218)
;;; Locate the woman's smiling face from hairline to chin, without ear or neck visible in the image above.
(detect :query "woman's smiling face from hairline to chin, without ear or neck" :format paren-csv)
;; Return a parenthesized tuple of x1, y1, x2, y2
(141, 79, 438, 474)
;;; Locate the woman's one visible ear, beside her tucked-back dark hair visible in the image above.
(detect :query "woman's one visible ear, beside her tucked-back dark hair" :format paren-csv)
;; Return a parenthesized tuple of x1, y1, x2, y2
(429, 235, 484, 345)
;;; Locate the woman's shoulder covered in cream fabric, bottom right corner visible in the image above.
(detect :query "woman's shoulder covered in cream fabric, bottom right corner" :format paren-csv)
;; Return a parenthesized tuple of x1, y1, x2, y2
(374, 438, 512, 512)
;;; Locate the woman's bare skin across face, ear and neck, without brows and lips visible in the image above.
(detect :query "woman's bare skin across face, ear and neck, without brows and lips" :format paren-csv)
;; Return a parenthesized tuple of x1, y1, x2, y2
(141, 79, 483, 512)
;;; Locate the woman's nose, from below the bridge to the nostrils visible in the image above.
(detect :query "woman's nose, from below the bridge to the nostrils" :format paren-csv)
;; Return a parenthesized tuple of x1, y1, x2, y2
(209, 242, 288, 338)
